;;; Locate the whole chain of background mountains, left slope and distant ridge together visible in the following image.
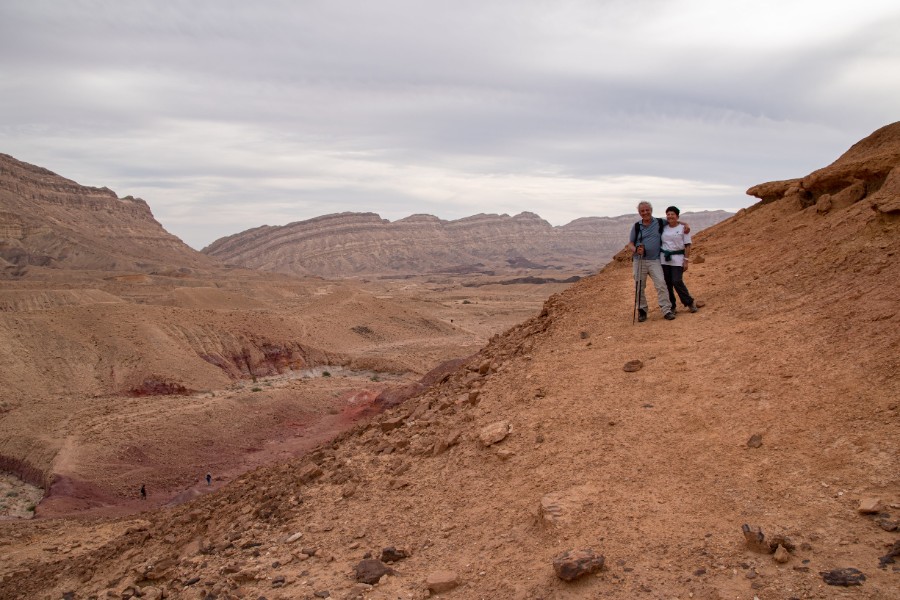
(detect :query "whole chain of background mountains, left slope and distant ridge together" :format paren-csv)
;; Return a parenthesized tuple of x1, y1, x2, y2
(0, 154, 732, 278)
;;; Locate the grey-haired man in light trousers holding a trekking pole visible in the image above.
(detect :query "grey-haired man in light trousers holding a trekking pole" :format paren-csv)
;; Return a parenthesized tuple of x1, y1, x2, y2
(627, 202, 675, 322)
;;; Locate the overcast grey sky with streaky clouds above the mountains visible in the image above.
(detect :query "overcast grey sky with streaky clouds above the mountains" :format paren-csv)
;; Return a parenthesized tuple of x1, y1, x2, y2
(0, 0, 900, 249)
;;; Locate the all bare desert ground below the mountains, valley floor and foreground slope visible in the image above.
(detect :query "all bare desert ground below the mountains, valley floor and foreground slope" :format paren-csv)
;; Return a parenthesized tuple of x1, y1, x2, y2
(0, 123, 900, 600)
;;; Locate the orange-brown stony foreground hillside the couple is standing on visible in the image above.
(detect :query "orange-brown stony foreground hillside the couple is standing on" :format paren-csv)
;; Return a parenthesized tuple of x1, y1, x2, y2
(0, 123, 900, 600)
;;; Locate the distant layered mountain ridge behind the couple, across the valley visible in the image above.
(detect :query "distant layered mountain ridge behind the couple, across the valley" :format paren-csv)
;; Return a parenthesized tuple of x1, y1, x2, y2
(203, 210, 733, 277)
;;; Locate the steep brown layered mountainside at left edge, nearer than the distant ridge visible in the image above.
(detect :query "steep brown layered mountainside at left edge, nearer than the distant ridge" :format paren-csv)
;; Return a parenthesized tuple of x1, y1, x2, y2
(0, 154, 215, 277)
